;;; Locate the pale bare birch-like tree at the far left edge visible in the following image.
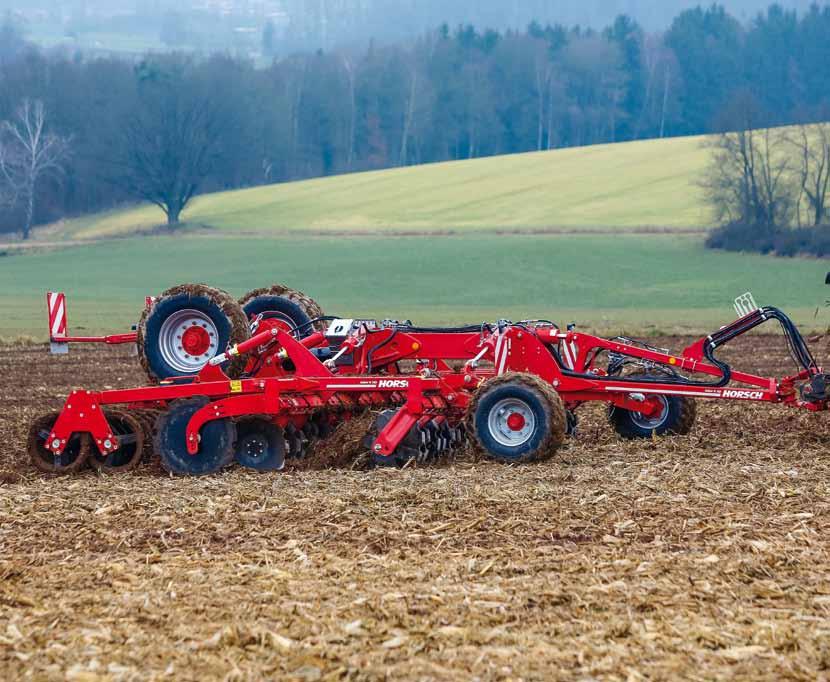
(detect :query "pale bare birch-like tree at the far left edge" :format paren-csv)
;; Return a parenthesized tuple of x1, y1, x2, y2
(0, 100, 70, 239)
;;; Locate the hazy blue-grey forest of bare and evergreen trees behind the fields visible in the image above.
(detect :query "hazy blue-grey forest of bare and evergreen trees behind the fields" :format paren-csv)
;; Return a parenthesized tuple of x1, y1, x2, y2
(0, 5, 830, 238)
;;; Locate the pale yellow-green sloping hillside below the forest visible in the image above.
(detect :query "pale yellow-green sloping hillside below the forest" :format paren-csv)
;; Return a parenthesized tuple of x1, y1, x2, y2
(42, 133, 709, 239)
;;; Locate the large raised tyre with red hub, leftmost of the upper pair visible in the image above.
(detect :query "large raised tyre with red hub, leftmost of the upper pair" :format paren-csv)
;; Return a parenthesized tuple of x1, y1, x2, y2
(137, 284, 251, 382)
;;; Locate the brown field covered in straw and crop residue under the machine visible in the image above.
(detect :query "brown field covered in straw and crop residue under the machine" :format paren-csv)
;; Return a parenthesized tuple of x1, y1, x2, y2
(0, 337, 830, 680)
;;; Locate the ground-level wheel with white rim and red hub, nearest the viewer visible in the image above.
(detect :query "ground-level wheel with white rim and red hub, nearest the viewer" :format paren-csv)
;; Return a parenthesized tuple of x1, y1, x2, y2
(467, 373, 567, 464)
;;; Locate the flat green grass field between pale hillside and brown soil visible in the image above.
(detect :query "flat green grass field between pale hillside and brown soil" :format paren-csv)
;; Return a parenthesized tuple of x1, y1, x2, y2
(0, 234, 827, 339)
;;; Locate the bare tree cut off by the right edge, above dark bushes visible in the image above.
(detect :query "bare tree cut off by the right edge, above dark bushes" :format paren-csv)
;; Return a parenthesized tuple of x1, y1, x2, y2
(787, 123, 830, 226)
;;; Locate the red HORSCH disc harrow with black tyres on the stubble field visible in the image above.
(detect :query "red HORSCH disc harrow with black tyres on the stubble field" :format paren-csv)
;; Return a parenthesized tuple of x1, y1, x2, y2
(29, 278, 830, 475)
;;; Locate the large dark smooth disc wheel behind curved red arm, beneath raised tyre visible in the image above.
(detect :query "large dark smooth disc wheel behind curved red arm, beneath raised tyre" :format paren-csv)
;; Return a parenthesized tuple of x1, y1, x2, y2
(155, 396, 236, 476)
